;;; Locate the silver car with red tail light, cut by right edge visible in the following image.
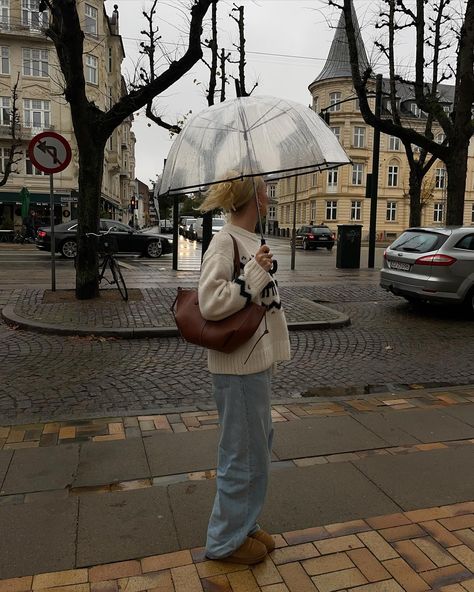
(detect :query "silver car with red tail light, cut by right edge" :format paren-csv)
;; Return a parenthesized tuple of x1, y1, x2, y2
(380, 226, 474, 313)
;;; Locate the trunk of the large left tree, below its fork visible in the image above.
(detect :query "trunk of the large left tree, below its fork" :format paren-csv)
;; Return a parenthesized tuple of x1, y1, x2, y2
(76, 136, 104, 300)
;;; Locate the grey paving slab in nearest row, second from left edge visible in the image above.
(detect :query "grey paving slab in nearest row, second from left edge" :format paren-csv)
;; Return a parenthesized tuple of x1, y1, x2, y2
(77, 487, 179, 567)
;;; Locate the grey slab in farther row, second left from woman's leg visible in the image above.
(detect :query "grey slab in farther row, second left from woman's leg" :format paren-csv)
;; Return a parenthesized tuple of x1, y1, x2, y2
(73, 438, 150, 487)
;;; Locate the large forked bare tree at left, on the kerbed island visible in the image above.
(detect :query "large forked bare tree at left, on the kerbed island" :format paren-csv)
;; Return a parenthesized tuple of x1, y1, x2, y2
(42, 0, 212, 299)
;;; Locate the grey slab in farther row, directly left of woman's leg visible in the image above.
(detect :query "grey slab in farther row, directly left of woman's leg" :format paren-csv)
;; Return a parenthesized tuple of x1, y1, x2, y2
(143, 430, 219, 477)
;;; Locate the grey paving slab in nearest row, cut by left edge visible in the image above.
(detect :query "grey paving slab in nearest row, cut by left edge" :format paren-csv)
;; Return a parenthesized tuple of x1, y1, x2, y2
(0, 499, 78, 578)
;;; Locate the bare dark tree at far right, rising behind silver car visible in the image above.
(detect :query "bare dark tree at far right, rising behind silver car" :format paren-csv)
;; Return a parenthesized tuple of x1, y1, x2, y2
(336, 0, 474, 224)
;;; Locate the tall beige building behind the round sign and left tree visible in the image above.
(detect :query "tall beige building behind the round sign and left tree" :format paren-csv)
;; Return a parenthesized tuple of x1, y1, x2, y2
(0, 0, 135, 227)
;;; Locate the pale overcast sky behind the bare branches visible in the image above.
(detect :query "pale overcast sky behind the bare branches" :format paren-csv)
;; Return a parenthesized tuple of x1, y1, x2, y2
(105, 0, 402, 184)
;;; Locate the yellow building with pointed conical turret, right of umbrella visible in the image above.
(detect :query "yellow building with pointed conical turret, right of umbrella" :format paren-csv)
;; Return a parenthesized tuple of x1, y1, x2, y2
(277, 5, 474, 240)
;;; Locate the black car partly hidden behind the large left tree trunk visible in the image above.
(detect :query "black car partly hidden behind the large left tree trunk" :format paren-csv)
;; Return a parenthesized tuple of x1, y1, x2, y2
(35, 220, 173, 259)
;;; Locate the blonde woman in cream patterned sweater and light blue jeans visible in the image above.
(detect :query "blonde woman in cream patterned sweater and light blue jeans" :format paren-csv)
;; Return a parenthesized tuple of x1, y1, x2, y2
(199, 171, 290, 564)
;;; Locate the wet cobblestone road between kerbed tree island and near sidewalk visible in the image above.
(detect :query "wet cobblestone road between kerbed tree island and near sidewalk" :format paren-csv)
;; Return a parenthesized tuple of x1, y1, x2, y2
(0, 283, 474, 423)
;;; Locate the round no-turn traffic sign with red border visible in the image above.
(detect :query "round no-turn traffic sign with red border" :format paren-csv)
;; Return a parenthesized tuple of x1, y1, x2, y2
(28, 132, 71, 174)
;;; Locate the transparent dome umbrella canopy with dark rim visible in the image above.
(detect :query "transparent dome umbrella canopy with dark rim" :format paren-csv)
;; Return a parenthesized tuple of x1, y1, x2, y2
(160, 96, 350, 195)
